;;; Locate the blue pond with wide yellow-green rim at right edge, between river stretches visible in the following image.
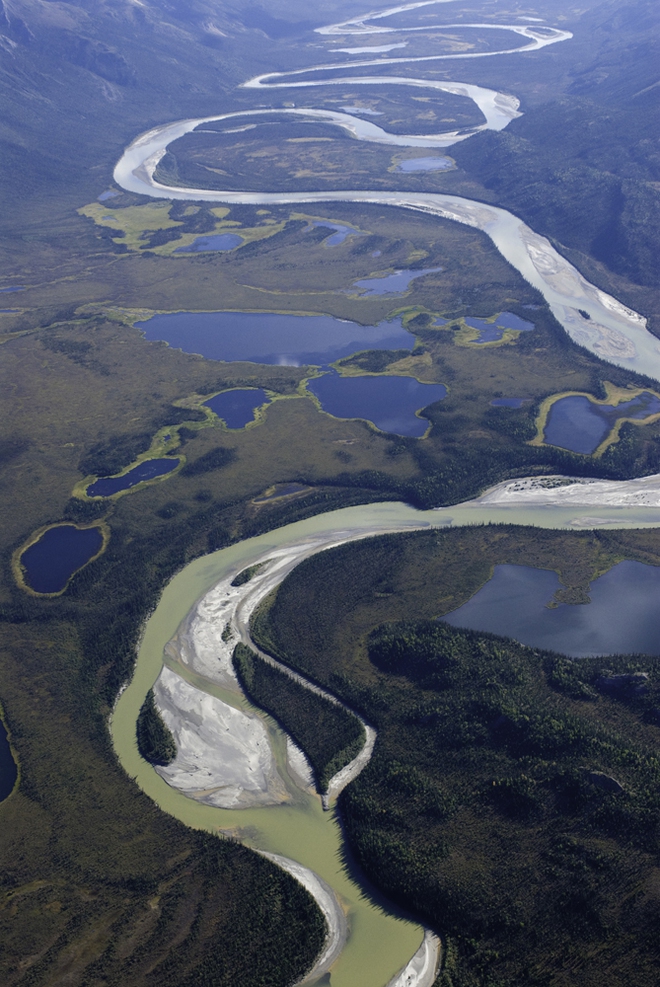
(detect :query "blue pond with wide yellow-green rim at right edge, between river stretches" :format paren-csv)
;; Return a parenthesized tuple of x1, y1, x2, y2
(543, 391, 660, 454)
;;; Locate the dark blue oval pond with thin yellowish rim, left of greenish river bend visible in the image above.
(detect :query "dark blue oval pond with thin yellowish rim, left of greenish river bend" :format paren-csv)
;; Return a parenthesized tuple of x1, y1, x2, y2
(21, 524, 103, 593)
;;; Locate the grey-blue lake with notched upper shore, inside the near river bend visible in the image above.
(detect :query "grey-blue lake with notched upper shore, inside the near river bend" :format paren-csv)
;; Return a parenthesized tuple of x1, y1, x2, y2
(442, 561, 660, 658)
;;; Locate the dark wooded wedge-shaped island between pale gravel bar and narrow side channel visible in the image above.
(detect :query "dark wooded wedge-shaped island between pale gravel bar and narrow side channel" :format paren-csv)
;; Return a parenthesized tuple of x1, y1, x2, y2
(234, 644, 365, 792)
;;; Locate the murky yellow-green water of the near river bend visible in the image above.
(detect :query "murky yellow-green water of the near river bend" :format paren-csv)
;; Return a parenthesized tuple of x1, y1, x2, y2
(111, 503, 660, 987)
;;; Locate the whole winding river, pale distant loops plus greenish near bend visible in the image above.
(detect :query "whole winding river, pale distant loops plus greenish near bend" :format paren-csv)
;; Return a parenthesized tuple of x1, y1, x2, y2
(111, 0, 660, 987)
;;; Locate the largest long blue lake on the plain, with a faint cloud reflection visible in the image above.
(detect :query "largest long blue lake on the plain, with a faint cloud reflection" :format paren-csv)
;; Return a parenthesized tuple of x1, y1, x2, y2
(136, 312, 415, 367)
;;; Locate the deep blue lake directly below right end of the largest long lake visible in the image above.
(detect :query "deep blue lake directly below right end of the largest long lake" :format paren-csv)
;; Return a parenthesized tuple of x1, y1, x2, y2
(307, 371, 447, 437)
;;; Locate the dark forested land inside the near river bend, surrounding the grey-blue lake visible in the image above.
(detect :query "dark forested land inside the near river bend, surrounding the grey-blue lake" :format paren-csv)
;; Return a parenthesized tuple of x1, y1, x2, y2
(255, 525, 660, 987)
